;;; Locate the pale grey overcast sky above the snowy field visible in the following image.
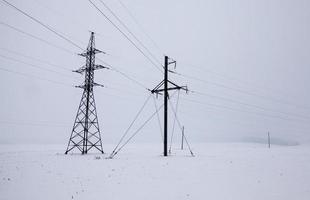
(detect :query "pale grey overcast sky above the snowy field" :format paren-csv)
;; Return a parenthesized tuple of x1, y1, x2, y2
(0, 0, 310, 145)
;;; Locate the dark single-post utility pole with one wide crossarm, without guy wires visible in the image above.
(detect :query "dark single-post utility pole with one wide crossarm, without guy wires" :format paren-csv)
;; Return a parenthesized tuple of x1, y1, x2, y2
(151, 56, 188, 156)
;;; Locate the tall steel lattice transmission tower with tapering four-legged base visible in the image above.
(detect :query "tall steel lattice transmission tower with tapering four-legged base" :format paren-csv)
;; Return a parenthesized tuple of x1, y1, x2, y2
(65, 32, 107, 154)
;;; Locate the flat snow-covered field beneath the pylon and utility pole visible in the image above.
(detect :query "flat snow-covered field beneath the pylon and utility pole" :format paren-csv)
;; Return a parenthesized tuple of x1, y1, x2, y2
(0, 143, 310, 200)
